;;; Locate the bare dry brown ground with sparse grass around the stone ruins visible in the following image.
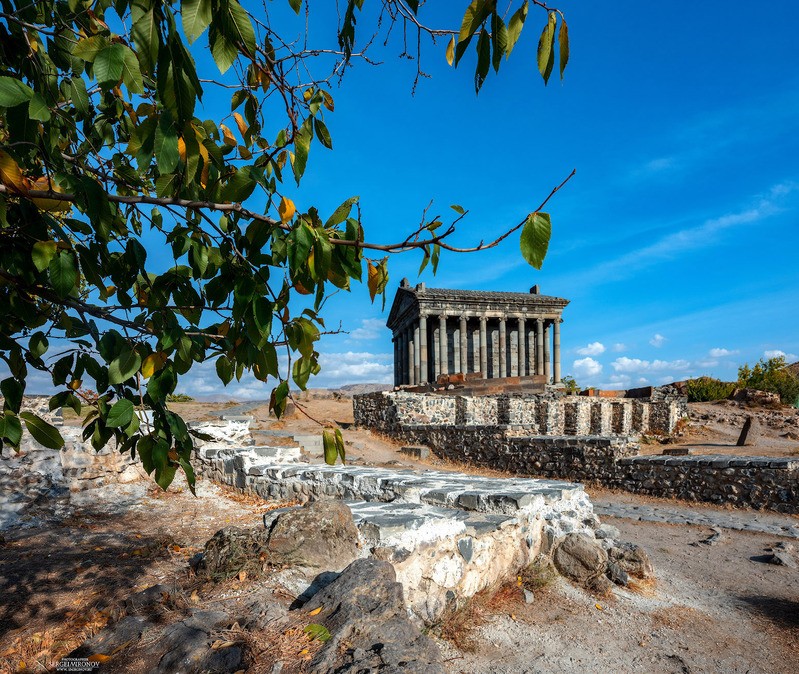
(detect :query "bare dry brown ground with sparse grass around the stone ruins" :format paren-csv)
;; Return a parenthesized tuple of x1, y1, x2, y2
(0, 395, 799, 674)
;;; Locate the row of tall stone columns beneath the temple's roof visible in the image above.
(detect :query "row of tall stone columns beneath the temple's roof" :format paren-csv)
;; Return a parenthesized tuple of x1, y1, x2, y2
(393, 315, 561, 385)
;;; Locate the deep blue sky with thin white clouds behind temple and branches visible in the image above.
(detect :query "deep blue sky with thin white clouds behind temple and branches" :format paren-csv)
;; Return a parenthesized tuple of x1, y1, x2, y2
(14, 0, 799, 398)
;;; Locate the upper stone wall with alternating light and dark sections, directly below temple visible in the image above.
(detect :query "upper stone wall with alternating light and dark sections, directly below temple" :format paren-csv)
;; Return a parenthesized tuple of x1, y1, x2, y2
(352, 391, 688, 436)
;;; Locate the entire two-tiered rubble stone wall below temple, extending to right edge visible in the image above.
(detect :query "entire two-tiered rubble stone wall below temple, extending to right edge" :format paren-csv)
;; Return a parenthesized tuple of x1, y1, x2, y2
(353, 391, 799, 513)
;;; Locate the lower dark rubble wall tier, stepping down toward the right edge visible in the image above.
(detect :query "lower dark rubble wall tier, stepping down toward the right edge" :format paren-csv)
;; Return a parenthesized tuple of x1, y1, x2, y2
(354, 406, 799, 513)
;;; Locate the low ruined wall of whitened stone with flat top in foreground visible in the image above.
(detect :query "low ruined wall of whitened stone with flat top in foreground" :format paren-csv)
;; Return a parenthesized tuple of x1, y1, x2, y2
(197, 446, 598, 623)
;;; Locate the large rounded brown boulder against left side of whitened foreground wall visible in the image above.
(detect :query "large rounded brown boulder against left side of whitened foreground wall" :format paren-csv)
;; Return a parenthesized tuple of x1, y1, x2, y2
(265, 500, 358, 571)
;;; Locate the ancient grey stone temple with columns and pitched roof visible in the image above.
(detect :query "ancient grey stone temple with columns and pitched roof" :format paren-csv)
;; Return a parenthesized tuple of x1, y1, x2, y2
(387, 279, 569, 385)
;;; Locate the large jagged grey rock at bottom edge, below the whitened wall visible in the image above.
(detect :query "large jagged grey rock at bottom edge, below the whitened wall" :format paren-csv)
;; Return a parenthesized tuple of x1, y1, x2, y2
(301, 559, 445, 674)
